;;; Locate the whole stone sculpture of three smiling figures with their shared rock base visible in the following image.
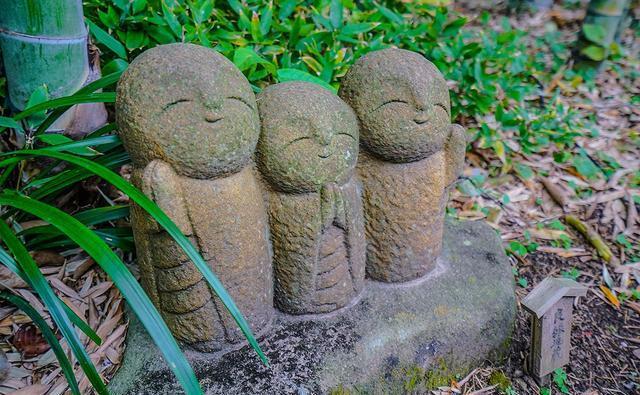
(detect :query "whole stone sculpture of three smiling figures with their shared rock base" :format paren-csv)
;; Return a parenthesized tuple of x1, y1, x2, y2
(109, 44, 520, 394)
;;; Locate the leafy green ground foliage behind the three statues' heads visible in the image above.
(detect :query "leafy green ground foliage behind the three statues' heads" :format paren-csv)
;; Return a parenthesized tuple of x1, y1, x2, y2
(85, 0, 582, 164)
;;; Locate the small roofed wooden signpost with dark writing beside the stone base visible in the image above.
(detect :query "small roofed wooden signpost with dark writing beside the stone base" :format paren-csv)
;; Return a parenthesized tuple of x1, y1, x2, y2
(522, 277, 587, 385)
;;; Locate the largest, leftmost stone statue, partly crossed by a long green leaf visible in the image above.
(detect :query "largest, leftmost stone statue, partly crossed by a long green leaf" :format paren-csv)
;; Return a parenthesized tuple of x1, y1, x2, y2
(116, 44, 273, 350)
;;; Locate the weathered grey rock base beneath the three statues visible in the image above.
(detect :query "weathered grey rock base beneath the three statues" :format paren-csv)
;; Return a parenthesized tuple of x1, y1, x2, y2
(110, 221, 516, 394)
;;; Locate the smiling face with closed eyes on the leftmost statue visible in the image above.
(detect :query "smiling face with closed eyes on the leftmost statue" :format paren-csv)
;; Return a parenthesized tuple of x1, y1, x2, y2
(152, 76, 259, 176)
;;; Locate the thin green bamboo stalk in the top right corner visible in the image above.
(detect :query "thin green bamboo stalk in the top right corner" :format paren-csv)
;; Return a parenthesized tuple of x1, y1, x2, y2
(576, 0, 630, 69)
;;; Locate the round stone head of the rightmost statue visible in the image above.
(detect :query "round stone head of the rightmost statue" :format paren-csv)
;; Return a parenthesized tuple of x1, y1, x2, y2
(339, 48, 450, 162)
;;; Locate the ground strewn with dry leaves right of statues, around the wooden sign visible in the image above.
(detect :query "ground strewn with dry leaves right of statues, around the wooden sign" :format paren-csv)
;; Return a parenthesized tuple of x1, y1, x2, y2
(442, 4, 640, 394)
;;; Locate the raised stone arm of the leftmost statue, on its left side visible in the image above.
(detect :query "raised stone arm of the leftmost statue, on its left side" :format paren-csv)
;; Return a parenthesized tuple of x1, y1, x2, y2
(142, 159, 193, 236)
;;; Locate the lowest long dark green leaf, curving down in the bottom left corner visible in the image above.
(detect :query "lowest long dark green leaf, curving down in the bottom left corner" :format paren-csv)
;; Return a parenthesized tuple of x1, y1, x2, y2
(0, 291, 80, 395)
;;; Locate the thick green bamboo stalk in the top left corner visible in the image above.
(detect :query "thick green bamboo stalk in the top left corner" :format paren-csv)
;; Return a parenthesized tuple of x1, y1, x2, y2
(0, 0, 89, 111)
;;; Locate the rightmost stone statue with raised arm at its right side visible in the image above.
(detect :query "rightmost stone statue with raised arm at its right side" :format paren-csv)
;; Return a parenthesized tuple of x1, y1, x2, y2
(339, 49, 466, 282)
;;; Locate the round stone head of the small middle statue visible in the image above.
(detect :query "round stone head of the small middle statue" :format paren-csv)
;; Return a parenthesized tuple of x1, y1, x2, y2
(258, 82, 358, 192)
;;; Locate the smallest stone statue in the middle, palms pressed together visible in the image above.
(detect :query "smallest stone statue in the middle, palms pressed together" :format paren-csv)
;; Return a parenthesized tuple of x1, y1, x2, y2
(256, 82, 365, 314)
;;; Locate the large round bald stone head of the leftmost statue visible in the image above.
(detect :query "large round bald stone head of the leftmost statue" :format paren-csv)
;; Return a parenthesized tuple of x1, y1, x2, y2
(116, 44, 260, 178)
